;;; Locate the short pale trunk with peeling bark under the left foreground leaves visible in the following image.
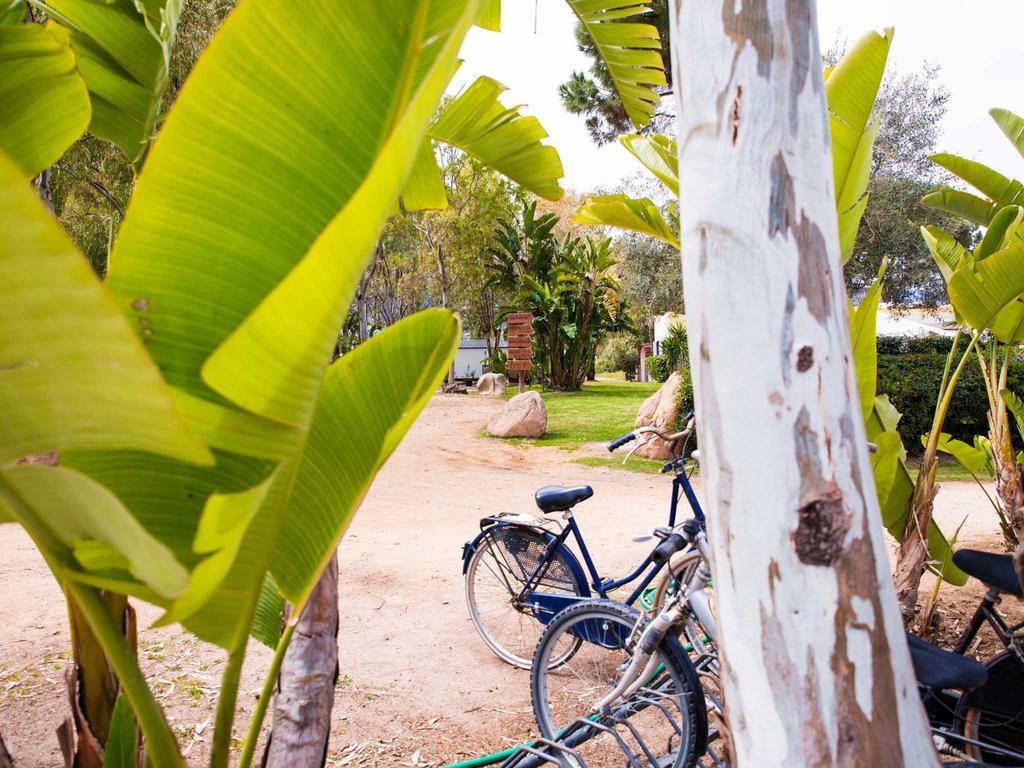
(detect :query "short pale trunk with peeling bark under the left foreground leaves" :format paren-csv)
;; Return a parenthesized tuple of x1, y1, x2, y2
(262, 554, 338, 768)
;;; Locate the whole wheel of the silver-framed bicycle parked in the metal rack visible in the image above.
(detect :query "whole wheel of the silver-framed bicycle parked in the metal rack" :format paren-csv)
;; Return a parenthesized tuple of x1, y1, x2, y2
(530, 600, 708, 768)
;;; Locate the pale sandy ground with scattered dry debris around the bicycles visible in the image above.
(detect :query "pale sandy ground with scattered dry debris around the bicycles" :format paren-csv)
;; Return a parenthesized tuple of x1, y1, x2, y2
(0, 395, 1015, 768)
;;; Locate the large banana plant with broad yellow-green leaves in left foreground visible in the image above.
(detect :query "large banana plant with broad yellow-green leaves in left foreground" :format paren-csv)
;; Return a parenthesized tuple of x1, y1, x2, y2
(0, 0, 536, 766)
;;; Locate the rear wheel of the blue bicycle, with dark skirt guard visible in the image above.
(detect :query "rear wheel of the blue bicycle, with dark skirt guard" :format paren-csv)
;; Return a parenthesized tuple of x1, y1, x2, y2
(466, 525, 584, 670)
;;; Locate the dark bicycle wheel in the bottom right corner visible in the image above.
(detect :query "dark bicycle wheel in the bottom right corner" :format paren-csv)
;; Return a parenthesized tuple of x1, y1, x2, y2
(956, 650, 1024, 766)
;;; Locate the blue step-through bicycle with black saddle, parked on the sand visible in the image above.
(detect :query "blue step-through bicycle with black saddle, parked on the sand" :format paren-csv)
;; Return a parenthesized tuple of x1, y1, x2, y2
(462, 417, 703, 669)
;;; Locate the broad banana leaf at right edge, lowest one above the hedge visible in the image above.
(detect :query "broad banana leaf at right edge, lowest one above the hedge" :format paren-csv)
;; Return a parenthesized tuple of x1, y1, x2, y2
(947, 244, 1024, 344)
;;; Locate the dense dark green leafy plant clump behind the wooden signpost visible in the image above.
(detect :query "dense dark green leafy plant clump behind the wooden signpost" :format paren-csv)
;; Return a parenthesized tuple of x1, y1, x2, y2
(487, 203, 633, 390)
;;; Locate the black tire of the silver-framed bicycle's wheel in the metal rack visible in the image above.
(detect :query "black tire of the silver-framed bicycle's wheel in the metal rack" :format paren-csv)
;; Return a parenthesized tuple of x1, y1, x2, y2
(530, 599, 708, 768)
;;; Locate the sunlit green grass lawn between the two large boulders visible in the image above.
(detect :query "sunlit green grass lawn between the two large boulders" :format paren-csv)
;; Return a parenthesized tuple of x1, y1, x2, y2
(508, 381, 660, 450)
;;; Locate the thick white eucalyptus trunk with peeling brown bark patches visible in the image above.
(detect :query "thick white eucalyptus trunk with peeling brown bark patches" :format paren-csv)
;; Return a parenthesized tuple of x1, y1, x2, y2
(670, 0, 938, 768)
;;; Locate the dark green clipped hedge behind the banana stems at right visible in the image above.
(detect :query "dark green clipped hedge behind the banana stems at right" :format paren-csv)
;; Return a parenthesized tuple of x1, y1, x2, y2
(878, 354, 1024, 454)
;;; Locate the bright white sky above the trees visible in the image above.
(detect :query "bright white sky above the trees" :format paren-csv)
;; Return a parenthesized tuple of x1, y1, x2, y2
(453, 0, 1024, 191)
